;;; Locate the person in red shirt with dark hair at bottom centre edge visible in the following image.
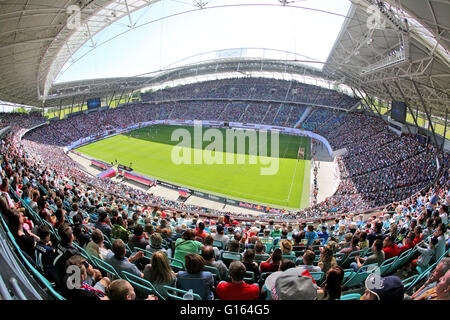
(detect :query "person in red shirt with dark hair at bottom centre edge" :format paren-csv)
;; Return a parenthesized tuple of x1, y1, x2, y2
(216, 260, 259, 300)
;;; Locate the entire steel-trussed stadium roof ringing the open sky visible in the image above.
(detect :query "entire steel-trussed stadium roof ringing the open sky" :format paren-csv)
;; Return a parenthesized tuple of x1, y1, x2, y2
(0, 0, 450, 121)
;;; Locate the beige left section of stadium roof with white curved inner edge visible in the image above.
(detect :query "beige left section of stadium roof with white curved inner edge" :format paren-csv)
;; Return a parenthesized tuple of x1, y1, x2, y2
(0, 0, 154, 106)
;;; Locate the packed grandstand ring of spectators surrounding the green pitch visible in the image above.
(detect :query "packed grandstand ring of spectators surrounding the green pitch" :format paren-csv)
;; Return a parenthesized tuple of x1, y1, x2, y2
(1, 74, 450, 299)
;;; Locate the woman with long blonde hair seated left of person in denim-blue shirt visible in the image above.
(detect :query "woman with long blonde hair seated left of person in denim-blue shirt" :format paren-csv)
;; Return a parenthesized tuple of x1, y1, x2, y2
(144, 251, 177, 296)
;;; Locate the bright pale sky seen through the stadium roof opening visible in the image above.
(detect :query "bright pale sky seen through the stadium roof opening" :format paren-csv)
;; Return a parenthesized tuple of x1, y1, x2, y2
(55, 0, 351, 83)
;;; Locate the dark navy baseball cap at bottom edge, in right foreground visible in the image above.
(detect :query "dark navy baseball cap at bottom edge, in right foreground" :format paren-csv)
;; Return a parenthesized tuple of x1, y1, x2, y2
(365, 274, 405, 300)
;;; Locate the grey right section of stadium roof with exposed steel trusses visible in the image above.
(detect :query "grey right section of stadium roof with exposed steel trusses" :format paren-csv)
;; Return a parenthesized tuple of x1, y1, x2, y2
(324, 0, 450, 116)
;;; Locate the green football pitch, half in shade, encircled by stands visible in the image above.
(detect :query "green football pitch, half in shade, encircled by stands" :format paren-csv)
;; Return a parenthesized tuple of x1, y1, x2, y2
(77, 125, 311, 209)
